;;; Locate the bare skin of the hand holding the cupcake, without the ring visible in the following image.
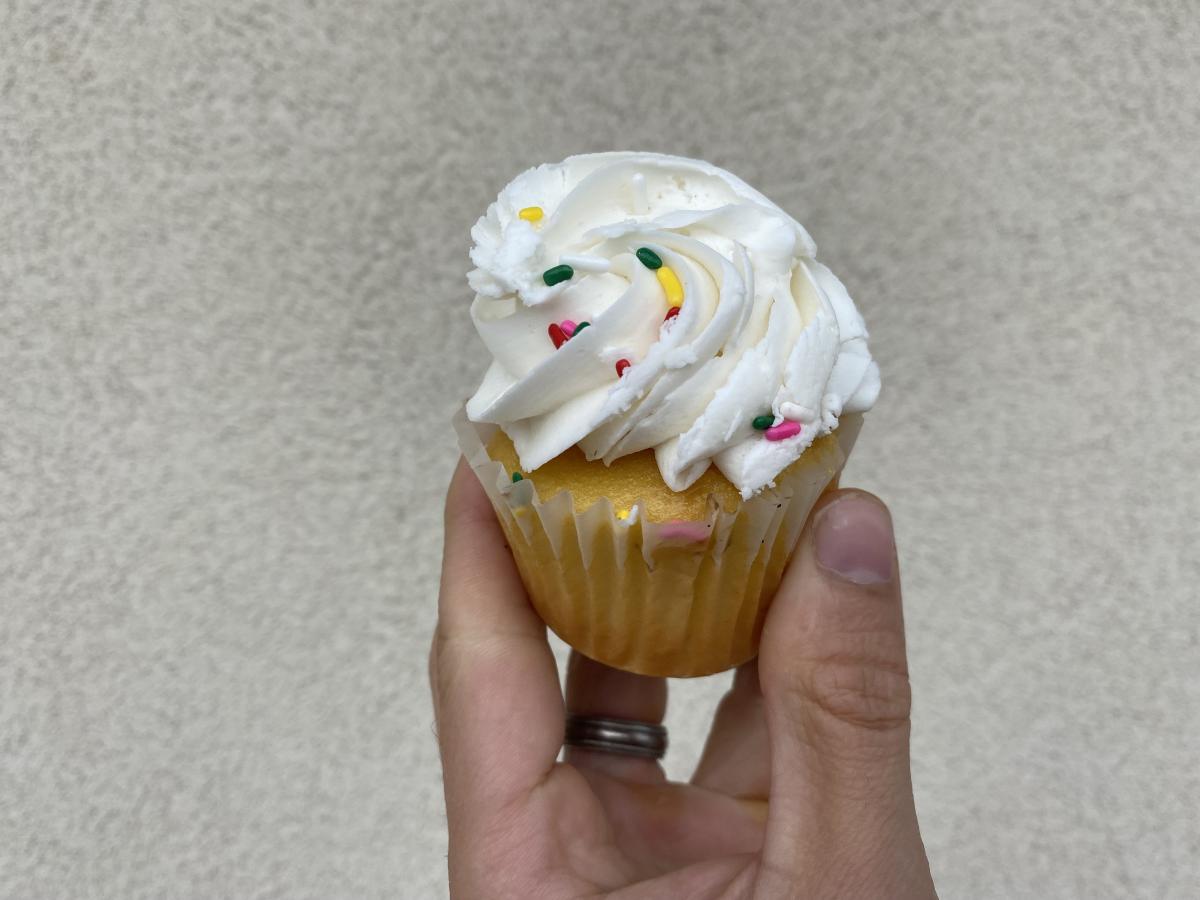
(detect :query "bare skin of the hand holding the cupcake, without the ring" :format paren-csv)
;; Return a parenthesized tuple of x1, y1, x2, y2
(430, 462, 936, 900)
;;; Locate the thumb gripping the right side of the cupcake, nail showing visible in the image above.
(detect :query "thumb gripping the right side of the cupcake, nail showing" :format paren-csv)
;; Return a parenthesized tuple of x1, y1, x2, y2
(758, 491, 934, 898)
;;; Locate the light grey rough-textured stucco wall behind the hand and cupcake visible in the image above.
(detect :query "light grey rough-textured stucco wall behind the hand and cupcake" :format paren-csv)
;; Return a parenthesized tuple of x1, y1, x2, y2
(0, 0, 1200, 900)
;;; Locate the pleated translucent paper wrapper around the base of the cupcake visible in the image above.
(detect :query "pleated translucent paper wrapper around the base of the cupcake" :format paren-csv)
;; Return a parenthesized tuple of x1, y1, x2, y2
(454, 410, 862, 677)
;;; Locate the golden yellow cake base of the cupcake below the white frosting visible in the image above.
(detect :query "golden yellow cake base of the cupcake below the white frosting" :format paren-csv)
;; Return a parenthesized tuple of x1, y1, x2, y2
(463, 430, 848, 677)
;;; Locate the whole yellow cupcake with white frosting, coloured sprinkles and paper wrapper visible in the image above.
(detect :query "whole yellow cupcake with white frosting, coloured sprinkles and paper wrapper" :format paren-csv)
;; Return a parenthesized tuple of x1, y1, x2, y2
(455, 152, 880, 677)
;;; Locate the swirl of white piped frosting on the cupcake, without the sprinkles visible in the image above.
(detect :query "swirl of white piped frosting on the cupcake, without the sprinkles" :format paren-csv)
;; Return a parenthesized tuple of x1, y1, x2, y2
(467, 152, 880, 497)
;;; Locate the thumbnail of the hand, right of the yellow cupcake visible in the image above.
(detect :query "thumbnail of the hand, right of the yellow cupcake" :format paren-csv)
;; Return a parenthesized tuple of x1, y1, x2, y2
(814, 493, 895, 584)
